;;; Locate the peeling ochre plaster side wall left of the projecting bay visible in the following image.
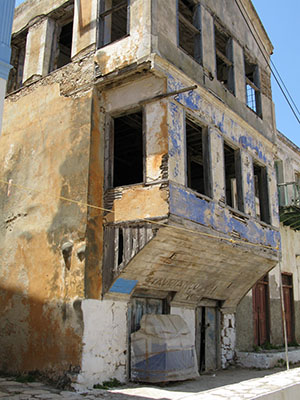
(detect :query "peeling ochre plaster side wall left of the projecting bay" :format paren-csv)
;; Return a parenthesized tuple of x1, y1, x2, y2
(0, 83, 91, 377)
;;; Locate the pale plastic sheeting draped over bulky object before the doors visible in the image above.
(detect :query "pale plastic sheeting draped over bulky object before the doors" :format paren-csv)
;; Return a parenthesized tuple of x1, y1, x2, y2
(131, 314, 199, 382)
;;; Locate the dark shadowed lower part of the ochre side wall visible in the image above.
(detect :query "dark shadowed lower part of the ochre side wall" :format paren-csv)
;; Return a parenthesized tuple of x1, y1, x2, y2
(0, 285, 83, 383)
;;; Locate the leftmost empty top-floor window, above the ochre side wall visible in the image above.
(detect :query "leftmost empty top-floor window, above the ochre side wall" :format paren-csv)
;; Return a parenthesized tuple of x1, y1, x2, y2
(6, 31, 27, 93)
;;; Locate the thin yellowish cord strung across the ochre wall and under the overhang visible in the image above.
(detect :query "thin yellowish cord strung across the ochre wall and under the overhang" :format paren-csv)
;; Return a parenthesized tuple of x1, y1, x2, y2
(0, 179, 279, 251)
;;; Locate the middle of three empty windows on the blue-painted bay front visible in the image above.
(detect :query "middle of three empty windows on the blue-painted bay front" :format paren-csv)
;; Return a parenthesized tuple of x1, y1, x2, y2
(224, 142, 244, 211)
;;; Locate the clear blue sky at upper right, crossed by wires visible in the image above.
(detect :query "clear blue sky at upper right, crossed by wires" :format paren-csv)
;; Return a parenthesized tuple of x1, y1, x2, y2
(16, 0, 300, 147)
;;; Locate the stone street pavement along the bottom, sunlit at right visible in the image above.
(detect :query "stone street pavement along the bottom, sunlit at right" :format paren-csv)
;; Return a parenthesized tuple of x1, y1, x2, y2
(0, 368, 300, 400)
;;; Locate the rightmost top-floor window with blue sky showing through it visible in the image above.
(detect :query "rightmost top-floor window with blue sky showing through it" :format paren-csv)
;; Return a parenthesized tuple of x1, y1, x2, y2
(244, 55, 262, 117)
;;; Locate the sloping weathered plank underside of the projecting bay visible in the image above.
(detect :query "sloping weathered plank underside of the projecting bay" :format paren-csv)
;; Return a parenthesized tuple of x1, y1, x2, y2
(106, 221, 279, 309)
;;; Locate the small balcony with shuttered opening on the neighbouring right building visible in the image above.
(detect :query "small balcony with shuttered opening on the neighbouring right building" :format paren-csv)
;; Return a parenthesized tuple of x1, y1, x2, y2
(278, 182, 300, 231)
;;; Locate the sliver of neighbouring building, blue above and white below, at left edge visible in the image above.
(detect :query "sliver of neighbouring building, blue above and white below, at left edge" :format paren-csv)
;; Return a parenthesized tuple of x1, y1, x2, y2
(0, 0, 15, 135)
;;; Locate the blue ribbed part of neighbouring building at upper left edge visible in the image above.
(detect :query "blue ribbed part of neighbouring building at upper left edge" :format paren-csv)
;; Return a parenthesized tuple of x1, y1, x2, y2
(0, 0, 15, 80)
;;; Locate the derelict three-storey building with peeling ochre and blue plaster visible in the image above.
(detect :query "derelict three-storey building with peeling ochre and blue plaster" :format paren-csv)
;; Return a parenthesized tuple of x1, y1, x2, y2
(0, 0, 300, 386)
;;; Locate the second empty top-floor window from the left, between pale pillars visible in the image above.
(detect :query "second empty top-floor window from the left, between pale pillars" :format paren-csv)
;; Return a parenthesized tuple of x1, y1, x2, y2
(49, 18, 73, 72)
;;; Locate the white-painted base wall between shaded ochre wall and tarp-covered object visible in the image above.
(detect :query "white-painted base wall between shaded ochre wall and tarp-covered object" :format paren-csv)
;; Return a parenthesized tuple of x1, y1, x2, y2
(74, 300, 128, 391)
